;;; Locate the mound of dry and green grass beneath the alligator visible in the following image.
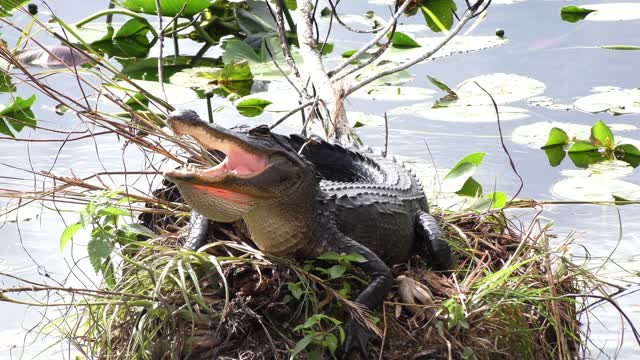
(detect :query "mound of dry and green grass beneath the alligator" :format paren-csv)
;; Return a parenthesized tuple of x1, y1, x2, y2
(56, 198, 599, 359)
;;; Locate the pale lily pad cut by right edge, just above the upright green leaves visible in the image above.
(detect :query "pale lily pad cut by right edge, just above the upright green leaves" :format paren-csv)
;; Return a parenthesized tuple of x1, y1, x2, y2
(574, 89, 640, 115)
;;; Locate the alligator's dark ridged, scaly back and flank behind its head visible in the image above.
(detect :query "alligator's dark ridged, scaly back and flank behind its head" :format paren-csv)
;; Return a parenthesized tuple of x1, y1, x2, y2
(289, 135, 427, 264)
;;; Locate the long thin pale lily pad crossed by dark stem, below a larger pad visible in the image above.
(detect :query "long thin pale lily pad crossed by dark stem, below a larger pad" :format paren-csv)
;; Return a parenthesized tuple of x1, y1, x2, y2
(389, 103, 528, 122)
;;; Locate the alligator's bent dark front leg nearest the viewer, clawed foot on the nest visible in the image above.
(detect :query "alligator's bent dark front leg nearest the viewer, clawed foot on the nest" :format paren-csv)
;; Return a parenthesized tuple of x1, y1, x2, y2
(327, 233, 393, 359)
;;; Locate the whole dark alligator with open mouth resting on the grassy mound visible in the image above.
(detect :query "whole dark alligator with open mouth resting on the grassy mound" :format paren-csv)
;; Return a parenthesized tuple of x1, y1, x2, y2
(164, 110, 452, 358)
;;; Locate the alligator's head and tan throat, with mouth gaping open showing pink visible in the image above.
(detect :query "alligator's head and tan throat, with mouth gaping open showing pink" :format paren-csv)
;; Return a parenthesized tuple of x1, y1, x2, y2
(164, 110, 317, 254)
